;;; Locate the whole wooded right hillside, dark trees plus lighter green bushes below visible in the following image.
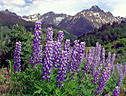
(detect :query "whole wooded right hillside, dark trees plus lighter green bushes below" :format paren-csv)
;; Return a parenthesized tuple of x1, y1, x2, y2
(78, 21, 126, 63)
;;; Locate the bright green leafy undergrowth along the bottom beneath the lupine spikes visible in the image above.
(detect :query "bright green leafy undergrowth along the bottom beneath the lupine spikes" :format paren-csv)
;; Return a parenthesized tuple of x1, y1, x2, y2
(10, 60, 118, 96)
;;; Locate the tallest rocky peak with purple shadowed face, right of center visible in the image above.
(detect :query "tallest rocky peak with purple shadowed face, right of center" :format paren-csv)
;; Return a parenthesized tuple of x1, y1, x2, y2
(58, 5, 124, 35)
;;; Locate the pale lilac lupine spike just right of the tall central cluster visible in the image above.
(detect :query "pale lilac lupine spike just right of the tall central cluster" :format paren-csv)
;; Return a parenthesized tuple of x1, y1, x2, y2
(84, 50, 93, 74)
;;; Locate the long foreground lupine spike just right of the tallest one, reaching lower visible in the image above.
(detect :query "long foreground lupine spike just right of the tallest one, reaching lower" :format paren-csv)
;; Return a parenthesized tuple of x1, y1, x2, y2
(42, 41, 53, 81)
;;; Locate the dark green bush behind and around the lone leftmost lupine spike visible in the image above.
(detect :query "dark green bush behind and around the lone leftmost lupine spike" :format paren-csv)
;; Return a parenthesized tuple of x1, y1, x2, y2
(0, 26, 32, 69)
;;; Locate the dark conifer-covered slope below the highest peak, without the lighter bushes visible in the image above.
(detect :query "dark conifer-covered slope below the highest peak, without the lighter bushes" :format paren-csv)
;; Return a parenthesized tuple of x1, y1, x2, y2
(78, 22, 126, 46)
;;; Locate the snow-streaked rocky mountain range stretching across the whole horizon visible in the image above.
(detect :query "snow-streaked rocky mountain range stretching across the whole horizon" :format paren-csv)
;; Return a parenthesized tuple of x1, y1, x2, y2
(0, 5, 126, 36)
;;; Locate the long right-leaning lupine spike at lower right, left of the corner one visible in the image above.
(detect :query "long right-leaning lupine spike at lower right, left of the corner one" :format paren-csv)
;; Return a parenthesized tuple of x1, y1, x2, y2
(95, 63, 111, 95)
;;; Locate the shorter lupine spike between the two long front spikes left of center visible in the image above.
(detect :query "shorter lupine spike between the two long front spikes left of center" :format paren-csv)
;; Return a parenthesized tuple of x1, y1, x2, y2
(53, 41, 62, 68)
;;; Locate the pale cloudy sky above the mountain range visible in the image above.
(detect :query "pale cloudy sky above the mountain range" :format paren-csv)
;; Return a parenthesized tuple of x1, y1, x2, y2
(0, 0, 126, 17)
